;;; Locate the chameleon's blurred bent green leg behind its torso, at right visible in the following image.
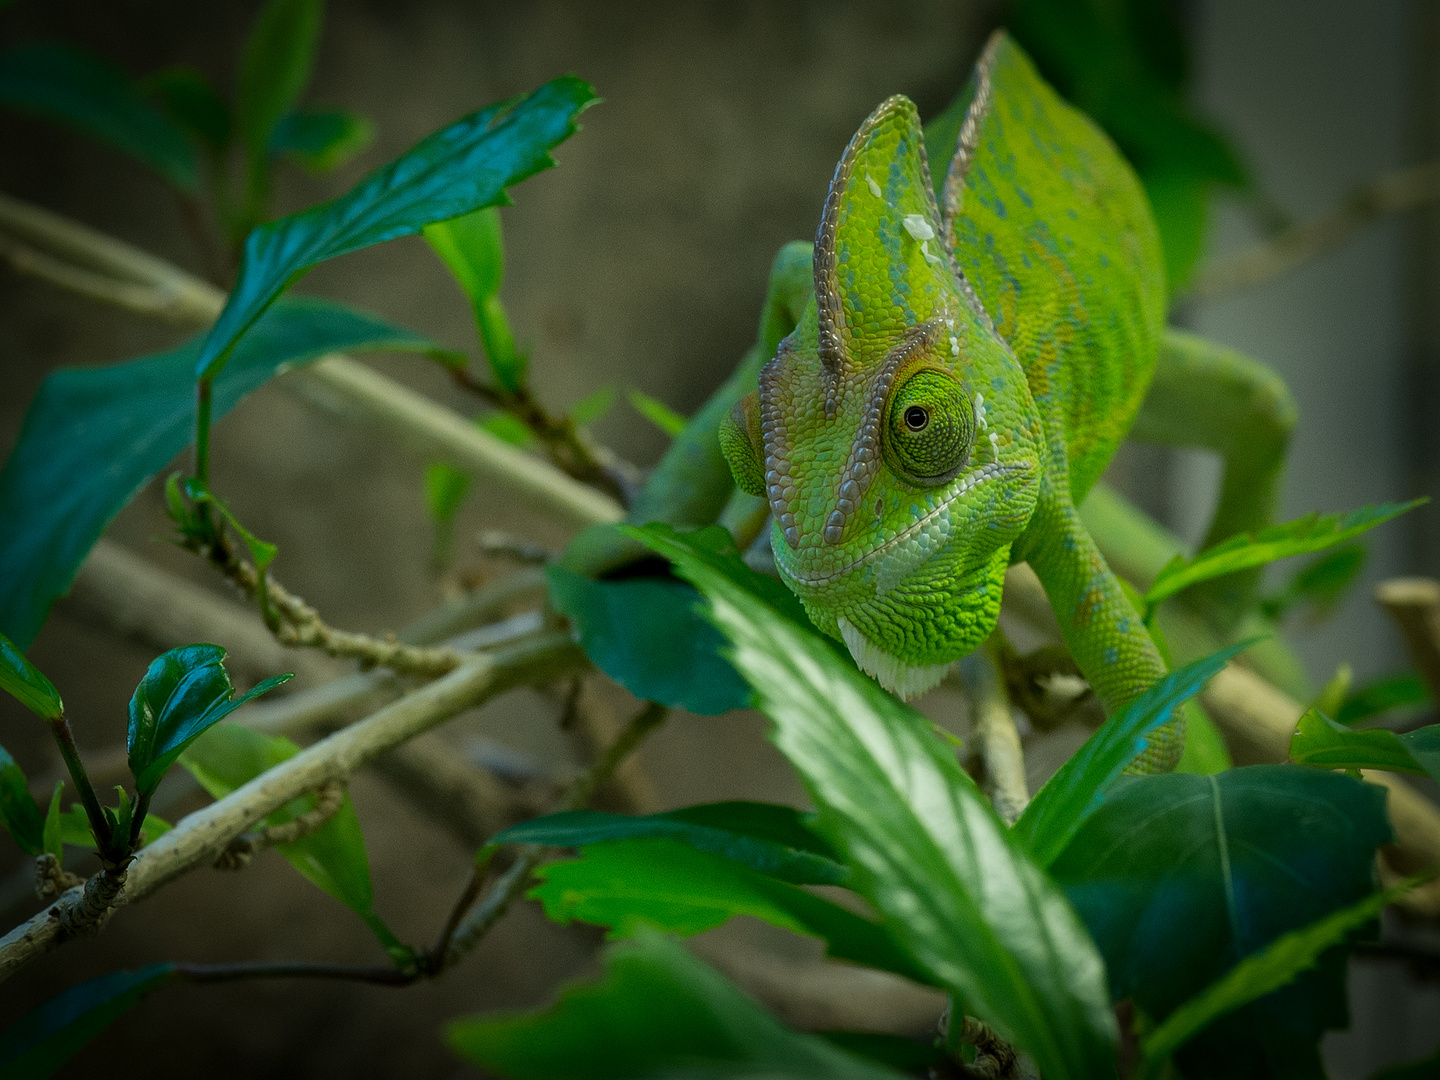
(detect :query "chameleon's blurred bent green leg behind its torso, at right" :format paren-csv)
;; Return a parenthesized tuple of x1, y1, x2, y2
(1130, 330, 1296, 634)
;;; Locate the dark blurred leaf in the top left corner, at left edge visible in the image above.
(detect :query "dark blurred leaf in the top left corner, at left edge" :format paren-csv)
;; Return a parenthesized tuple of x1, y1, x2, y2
(0, 43, 200, 192)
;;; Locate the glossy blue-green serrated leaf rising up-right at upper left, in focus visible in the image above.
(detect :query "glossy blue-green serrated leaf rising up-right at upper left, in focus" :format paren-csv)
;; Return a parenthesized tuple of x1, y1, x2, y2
(196, 75, 595, 379)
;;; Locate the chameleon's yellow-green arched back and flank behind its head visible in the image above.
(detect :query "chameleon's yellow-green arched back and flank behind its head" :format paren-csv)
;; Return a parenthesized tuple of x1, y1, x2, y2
(930, 32, 1165, 504)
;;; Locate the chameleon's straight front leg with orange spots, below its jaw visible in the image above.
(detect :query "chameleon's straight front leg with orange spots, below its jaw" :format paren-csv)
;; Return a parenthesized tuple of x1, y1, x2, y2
(1015, 478, 1185, 772)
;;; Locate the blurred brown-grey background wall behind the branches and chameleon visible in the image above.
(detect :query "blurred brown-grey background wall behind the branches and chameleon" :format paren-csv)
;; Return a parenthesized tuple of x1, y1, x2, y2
(0, 0, 1440, 1080)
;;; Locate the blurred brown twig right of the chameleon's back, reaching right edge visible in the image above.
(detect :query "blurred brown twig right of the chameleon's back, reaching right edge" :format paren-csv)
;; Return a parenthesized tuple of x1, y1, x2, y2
(1187, 161, 1440, 300)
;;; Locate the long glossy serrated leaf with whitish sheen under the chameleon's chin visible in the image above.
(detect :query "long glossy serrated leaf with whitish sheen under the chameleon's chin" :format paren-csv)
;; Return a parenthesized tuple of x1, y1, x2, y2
(636, 527, 1116, 1080)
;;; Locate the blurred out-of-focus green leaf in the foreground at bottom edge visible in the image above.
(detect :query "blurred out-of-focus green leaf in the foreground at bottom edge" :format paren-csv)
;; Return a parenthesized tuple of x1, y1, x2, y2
(445, 933, 900, 1080)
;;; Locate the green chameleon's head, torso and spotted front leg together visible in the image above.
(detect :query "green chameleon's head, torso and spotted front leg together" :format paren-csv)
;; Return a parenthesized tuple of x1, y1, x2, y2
(720, 35, 1182, 769)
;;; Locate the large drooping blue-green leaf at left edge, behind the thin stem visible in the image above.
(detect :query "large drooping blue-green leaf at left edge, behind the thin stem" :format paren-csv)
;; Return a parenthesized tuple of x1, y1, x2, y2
(0, 300, 457, 648)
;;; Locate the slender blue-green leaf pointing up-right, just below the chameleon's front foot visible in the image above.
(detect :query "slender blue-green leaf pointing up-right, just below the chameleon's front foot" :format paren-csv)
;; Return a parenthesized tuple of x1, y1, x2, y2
(1014, 641, 1251, 867)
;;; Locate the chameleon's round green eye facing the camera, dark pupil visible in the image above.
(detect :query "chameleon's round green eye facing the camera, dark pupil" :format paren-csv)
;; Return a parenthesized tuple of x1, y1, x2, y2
(886, 369, 975, 485)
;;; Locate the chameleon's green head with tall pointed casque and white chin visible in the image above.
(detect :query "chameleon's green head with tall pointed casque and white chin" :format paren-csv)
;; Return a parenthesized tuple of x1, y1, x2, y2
(721, 96, 1044, 697)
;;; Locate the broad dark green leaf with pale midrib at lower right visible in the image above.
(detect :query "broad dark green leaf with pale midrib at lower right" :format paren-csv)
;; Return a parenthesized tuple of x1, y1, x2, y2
(1050, 765, 1391, 1080)
